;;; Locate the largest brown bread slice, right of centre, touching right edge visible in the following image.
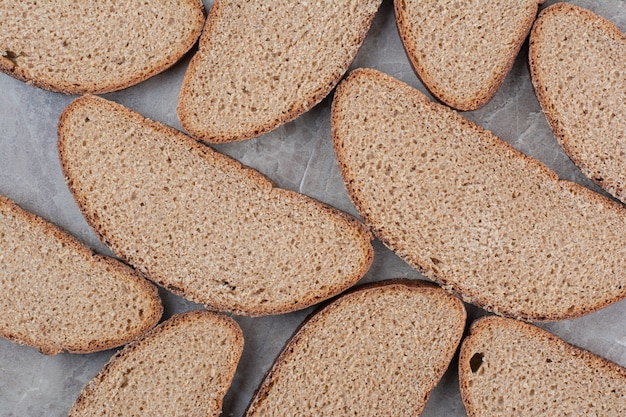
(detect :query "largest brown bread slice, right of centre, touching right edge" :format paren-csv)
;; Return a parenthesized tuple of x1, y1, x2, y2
(331, 70, 626, 320)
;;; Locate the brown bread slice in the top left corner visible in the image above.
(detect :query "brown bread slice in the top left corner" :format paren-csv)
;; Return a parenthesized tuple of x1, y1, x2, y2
(0, 0, 204, 94)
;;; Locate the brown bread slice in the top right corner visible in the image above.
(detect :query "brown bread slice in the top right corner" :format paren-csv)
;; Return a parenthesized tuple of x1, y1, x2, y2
(529, 3, 626, 203)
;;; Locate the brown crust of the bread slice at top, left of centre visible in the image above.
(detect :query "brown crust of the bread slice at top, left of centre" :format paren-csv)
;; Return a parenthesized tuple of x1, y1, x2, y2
(177, 0, 374, 143)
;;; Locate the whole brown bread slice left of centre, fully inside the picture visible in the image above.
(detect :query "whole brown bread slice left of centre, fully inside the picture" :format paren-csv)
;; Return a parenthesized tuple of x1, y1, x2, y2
(59, 97, 373, 315)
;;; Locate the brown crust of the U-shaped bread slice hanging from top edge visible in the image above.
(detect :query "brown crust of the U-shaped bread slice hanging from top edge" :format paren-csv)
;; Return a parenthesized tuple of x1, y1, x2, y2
(394, 0, 545, 111)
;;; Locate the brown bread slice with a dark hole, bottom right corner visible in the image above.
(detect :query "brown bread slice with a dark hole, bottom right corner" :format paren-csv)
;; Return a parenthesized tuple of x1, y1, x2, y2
(459, 317, 626, 417)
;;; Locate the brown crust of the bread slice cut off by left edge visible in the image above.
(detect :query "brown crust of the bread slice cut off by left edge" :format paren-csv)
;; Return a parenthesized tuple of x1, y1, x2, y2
(0, 195, 163, 355)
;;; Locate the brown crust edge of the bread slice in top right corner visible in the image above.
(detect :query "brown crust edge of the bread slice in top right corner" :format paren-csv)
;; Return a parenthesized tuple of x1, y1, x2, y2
(528, 2, 626, 203)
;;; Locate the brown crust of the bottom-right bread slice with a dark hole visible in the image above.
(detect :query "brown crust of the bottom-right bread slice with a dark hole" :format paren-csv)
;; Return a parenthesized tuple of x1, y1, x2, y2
(458, 316, 626, 417)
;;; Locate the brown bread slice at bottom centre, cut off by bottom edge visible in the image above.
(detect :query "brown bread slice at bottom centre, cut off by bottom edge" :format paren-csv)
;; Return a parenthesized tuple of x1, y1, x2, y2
(246, 280, 466, 417)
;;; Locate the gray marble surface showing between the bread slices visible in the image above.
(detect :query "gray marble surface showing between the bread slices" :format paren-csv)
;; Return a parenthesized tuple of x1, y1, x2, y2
(0, 0, 626, 417)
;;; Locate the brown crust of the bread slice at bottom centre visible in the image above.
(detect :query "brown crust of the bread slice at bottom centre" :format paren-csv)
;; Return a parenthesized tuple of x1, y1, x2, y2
(244, 278, 467, 417)
